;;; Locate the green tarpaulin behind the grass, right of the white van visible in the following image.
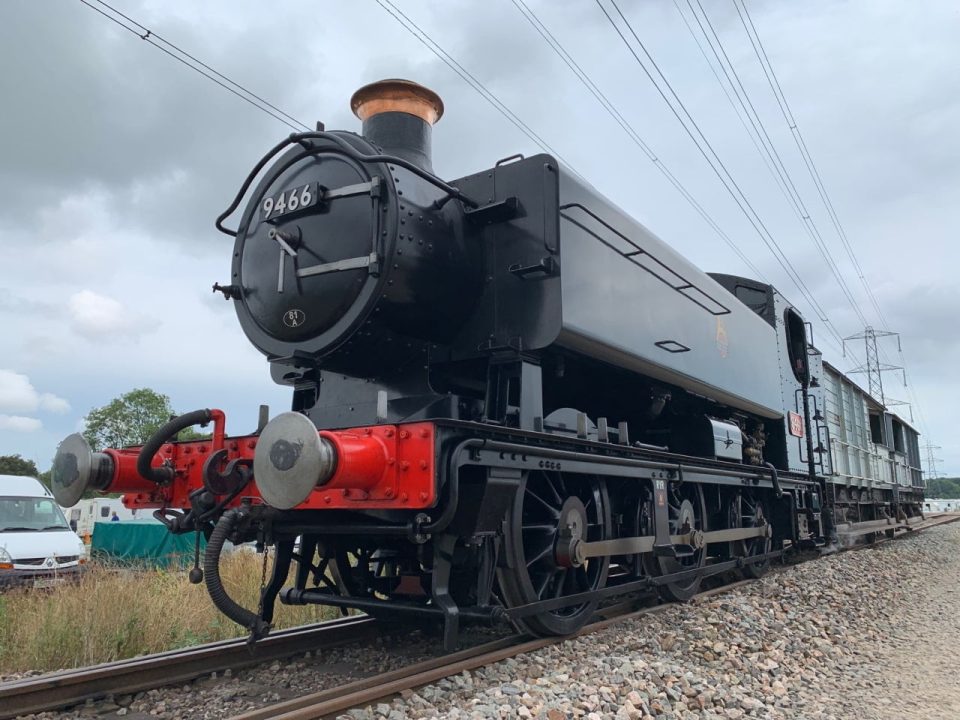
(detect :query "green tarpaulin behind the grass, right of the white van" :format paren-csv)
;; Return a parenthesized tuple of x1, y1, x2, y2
(90, 522, 206, 566)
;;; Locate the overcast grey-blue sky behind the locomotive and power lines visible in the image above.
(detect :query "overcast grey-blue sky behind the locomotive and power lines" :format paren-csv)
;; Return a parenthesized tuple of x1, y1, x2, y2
(0, 0, 960, 475)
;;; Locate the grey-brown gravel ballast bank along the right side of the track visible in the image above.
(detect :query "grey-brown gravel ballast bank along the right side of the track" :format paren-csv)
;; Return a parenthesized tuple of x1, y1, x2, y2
(341, 524, 960, 720)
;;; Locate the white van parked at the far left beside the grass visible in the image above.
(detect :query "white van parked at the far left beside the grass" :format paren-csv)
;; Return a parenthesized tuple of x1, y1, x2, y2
(0, 475, 85, 587)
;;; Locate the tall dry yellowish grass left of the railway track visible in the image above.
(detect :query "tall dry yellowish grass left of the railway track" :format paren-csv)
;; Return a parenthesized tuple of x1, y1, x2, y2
(0, 551, 338, 675)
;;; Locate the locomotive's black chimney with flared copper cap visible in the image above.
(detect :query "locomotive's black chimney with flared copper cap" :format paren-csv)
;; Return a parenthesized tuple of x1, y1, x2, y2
(350, 80, 443, 173)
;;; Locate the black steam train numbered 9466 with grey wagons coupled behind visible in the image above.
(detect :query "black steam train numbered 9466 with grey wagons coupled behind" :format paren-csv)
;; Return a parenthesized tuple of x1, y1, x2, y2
(52, 80, 922, 646)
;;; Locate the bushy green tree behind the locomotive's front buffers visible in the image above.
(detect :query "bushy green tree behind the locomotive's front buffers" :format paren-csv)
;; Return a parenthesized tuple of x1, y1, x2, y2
(83, 388, 180, 450)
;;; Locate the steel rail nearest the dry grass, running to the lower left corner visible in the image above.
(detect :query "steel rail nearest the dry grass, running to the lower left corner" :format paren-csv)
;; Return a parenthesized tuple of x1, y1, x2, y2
(0, 615, 377, 718)
